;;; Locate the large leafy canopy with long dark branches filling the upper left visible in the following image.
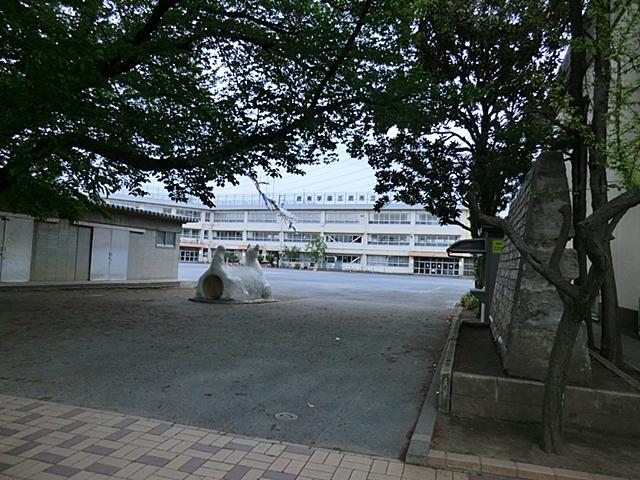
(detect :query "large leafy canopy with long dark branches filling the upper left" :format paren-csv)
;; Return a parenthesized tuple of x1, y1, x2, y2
(0, 0, 404, 216)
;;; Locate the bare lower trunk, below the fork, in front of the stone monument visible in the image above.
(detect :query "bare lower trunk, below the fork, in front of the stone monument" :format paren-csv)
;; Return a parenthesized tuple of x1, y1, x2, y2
(542, 300, 589, 453)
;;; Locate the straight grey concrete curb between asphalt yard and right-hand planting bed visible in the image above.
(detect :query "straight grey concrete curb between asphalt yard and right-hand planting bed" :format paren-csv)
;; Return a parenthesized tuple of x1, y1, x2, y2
(404, 307, 462, 466)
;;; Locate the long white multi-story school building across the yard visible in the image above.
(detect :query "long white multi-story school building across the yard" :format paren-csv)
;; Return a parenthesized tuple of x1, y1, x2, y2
(109, 193, 473, 276)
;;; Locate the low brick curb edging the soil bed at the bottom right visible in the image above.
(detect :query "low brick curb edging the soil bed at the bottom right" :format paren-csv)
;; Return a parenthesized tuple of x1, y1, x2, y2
(428, 450, 625, 480)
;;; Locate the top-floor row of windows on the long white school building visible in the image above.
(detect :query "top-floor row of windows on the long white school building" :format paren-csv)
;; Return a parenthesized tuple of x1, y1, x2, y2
(175, 207, 439, 225)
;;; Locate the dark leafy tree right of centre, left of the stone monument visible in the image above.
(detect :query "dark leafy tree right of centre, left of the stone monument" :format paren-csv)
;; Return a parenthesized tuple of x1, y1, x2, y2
(353, 0, 562, 235)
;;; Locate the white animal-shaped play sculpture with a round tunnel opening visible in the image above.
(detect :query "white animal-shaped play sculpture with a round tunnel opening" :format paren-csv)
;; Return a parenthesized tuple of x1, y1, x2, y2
(194, 245, 273, 302)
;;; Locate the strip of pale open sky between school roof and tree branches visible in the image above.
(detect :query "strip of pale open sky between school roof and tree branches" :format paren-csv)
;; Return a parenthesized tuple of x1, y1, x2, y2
(148, 151, 376, 196)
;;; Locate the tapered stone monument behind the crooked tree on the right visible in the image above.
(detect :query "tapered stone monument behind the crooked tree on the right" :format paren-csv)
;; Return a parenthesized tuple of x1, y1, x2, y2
(490, 152, 591, 384)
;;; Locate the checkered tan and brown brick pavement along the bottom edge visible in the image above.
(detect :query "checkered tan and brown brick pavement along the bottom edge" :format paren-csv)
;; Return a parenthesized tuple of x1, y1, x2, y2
(0, 395, 628, 480)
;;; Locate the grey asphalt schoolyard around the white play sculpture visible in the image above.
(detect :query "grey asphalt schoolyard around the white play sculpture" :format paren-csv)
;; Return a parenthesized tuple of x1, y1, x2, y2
(0, 266, 470, 458)
